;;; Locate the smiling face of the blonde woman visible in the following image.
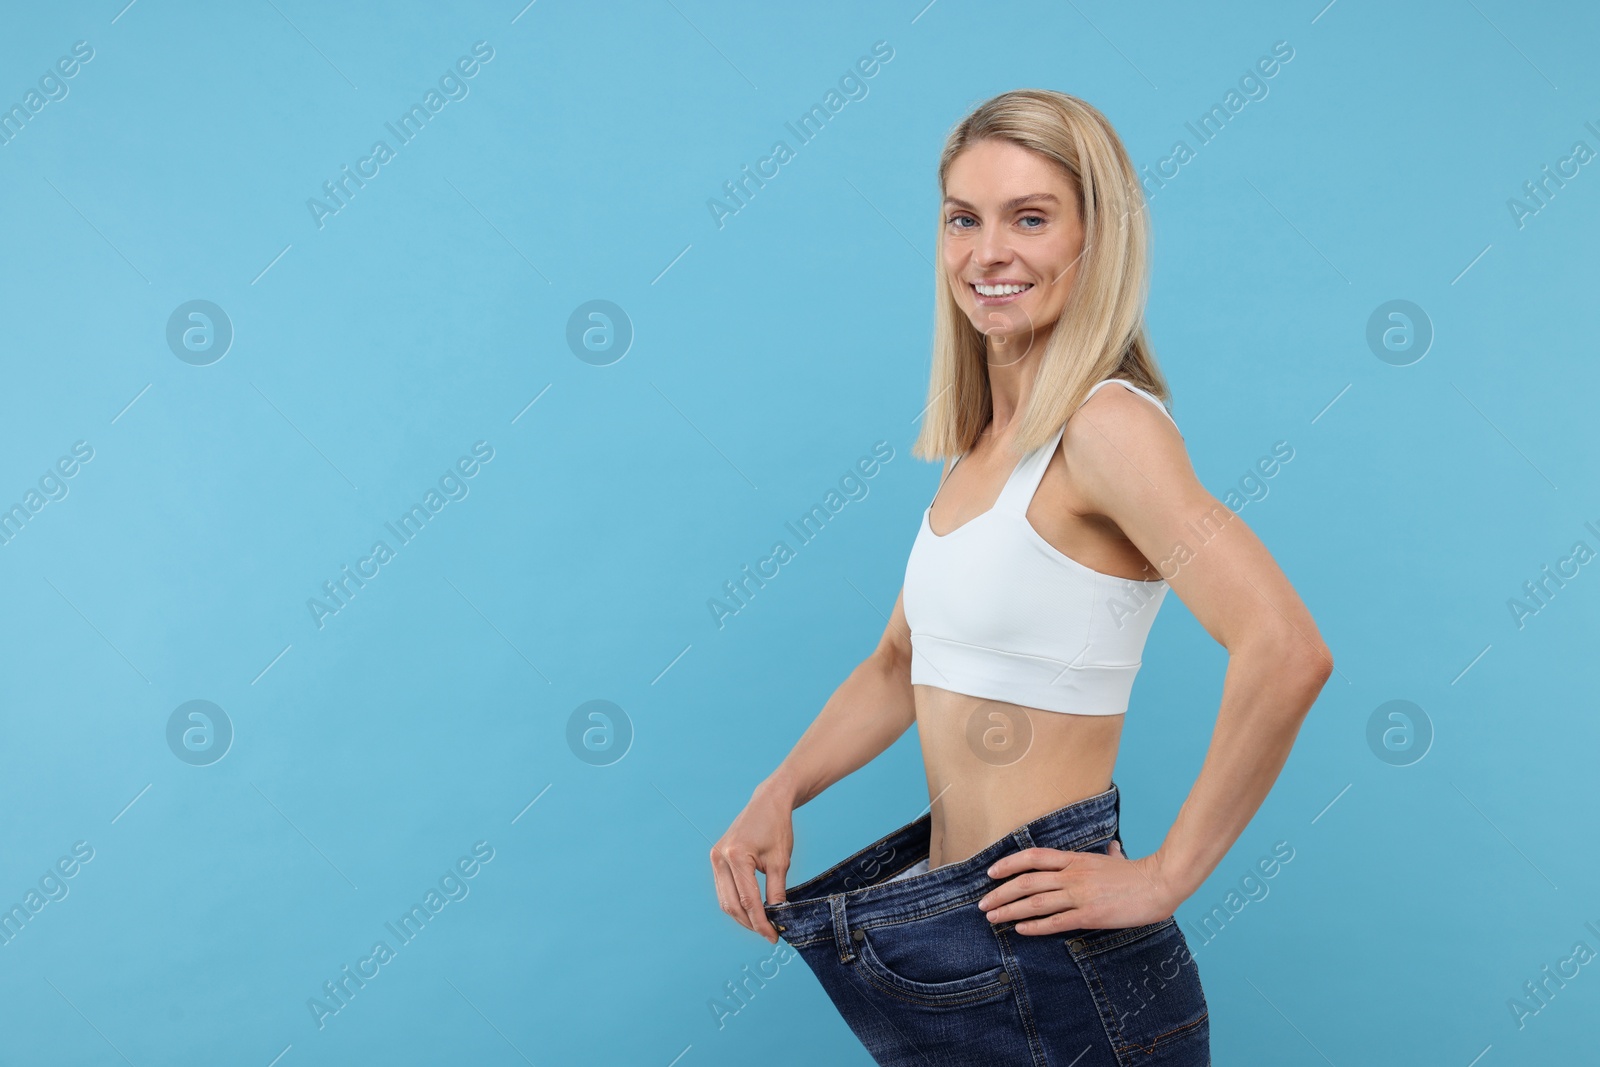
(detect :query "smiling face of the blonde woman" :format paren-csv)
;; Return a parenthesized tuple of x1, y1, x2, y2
(944, 139, 1083, 362)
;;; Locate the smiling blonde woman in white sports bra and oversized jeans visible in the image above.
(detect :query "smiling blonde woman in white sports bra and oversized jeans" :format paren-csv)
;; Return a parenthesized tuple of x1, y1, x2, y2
(710, 90, 1333, 1067)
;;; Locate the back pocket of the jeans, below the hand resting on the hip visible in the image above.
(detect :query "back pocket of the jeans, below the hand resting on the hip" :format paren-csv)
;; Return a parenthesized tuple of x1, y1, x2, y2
(1066, 917, 1210, 1064)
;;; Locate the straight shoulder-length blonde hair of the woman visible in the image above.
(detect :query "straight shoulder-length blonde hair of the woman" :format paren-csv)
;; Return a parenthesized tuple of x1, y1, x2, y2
(912, 90, 1171, 459)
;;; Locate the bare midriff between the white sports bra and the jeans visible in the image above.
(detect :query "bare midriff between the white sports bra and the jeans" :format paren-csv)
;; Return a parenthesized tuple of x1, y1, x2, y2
(912, 685, 1123, 869)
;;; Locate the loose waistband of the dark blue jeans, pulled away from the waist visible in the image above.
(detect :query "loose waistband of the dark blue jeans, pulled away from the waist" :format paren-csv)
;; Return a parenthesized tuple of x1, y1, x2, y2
(766, 782, 1122, 947)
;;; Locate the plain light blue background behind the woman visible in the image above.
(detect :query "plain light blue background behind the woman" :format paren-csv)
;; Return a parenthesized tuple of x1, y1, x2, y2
(0, 0, 1600, 1067)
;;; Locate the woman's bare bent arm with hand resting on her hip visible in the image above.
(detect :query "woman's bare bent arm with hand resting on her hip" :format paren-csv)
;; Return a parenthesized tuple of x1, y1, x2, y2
(979, 389, 1333, 934)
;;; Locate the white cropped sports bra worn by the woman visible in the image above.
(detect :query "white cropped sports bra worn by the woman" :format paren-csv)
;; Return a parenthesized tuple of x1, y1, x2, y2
(904, 378, 1176, 715)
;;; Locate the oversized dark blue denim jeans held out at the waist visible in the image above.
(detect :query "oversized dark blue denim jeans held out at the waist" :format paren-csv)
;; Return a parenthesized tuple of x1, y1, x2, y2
(766, 784, 1211, 1067)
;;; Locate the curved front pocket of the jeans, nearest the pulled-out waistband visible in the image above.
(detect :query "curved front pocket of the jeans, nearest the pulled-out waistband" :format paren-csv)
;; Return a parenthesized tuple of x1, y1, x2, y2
(850, 902, 1010, 1003)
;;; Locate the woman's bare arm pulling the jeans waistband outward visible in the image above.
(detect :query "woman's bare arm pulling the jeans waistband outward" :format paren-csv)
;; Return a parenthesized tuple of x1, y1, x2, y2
(710, 592, 917, 944)
